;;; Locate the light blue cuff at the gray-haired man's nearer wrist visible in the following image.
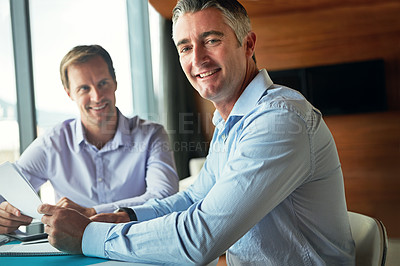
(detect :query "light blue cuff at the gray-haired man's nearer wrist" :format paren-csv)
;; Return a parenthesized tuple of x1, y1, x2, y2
(82, 222, 115, 258)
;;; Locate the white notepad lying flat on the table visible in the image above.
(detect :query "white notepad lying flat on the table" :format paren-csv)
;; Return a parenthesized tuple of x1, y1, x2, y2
(0, 240, 69, 257)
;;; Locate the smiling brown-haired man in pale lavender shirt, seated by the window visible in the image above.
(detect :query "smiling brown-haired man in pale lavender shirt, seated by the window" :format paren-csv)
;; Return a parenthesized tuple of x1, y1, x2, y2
(0, 45, 178, 233)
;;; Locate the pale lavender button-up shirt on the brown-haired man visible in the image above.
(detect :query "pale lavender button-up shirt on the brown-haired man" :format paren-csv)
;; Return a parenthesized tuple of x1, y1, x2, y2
(2, 110, 179, 213)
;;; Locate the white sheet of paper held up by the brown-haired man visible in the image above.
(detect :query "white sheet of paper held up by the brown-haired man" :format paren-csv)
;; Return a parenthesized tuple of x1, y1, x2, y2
(0, 162, 43, 220)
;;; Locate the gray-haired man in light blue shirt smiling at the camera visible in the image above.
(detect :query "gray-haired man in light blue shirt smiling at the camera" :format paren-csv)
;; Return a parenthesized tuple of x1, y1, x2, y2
(39, 0, 355, 265)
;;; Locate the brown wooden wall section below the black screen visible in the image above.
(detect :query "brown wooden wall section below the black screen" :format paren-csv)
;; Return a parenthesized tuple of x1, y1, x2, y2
(325, 111, 400, 238)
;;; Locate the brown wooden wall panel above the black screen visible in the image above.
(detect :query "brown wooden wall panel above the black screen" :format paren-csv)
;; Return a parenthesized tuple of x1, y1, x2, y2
(252, 2, 400, 110)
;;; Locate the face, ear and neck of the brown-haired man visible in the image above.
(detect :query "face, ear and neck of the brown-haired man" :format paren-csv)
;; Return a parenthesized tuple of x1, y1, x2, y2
(61, 52, 118, 149)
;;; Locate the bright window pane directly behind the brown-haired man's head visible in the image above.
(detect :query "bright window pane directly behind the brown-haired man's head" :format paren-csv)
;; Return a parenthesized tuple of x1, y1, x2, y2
(29, 0, 133, 135)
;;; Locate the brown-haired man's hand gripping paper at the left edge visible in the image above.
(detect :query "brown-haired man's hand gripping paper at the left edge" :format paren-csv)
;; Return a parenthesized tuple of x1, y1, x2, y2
(0, 201, 32, 234)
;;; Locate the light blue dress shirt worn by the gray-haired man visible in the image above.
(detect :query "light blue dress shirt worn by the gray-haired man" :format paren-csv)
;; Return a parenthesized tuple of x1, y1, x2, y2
(82, 70, 355, 266)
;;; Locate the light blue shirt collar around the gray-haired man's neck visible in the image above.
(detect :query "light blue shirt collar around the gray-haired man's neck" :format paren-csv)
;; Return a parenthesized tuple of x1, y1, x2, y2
(212, 69, 273, 126)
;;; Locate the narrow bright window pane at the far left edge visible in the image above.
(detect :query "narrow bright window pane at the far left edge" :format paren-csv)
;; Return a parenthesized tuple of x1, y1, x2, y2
(0, 0, 19, 163)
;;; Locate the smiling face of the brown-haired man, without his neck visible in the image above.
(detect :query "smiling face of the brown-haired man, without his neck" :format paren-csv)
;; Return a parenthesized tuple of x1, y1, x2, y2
(66, 56, 117, 128)
